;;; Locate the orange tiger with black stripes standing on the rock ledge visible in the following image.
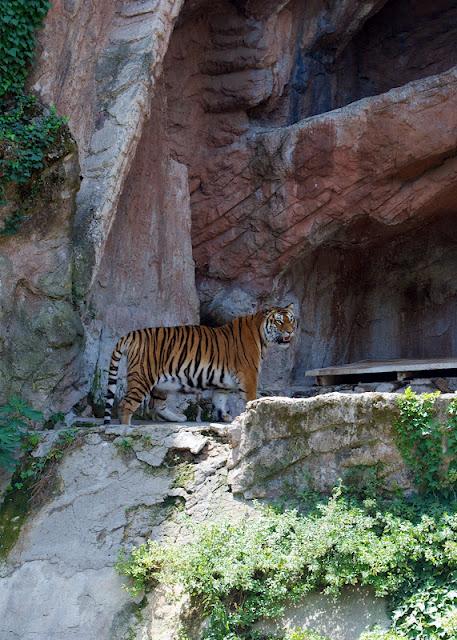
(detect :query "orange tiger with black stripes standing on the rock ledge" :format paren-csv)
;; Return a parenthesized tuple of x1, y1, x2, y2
(104, 304, 297, 425)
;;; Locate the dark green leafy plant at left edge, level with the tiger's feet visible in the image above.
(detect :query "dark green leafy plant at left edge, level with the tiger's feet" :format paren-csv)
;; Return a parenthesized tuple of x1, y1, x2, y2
(0, 396, 43, 471)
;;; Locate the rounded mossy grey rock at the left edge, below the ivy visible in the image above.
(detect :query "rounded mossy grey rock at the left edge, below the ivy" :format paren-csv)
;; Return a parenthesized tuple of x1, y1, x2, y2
(0, 130, 83, 412)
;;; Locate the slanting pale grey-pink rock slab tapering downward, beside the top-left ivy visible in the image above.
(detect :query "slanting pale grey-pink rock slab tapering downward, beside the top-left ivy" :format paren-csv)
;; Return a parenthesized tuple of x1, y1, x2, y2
(31, 0, 182, 295)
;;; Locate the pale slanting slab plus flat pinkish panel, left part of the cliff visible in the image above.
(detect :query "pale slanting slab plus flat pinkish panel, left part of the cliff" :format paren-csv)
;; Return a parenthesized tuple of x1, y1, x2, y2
(30, 0, 199, 402)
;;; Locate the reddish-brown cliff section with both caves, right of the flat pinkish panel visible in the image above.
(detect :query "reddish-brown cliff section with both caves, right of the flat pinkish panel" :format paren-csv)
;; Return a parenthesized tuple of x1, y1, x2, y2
(159, 0, 457, 393)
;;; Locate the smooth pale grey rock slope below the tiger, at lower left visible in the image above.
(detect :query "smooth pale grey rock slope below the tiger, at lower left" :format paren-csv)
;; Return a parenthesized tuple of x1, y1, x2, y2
(0, 424, 237, 640)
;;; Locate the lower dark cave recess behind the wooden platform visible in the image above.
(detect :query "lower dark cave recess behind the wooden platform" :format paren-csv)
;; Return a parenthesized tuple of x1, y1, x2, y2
(281, 213, 457, 385)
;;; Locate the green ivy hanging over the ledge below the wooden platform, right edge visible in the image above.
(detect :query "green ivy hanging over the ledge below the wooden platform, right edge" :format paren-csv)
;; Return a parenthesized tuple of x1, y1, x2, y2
(394, 387, 457, 493)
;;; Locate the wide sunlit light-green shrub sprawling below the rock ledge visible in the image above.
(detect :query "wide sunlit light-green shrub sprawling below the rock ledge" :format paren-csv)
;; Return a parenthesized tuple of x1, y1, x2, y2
(117, 490, 457, 640)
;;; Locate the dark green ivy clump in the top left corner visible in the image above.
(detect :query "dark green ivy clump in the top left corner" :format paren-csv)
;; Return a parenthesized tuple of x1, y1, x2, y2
(0, 0, 51, 98)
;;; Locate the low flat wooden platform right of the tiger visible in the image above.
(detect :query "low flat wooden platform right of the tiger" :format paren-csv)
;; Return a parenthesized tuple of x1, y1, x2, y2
(305, 358, 457, 386)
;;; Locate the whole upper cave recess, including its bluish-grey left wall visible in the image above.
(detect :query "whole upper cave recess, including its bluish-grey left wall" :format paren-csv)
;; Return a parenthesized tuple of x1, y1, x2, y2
(249, 0, 457, 126)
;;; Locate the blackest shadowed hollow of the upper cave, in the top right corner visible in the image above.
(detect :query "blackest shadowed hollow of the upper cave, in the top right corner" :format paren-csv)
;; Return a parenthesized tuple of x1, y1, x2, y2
(333, 0, 457, 108)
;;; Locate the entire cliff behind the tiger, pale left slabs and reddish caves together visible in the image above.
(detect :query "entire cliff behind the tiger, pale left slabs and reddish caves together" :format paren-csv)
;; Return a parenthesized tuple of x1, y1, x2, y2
(1, 0, 457, 407)
